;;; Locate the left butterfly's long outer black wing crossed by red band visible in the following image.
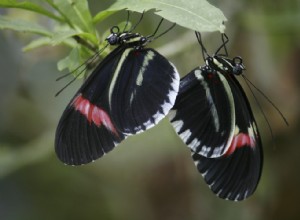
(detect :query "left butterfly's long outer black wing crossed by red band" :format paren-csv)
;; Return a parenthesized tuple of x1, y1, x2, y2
(55, 47, 125, 165)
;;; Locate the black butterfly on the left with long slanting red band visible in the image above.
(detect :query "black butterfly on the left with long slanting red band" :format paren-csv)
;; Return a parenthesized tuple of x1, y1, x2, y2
(55, 13, 180, 165)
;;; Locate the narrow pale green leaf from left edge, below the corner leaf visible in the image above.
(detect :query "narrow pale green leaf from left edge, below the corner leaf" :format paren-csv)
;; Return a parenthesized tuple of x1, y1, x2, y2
(0, 15, 52, 37)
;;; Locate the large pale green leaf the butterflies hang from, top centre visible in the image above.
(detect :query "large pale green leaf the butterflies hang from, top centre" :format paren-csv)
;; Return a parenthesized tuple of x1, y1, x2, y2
(107, 0, 227, 32)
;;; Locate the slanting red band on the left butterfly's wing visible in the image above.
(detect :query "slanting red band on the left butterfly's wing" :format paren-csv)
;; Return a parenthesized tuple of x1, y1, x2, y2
(72, 94, 118, 136)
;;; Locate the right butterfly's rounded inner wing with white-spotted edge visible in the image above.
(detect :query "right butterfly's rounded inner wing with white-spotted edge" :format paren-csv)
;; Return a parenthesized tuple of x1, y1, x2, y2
(170, 67, 235, 158)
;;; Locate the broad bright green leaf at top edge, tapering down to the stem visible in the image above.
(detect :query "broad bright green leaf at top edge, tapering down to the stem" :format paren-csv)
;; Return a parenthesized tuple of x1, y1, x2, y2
(48, 0, 95, 34)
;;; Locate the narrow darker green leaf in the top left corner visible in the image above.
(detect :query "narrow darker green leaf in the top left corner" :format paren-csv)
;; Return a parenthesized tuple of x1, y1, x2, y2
(0, 0, 63, 21)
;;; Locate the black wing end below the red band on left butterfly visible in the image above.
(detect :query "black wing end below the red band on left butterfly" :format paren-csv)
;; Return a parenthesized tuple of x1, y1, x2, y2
(55, 108, 125, 165)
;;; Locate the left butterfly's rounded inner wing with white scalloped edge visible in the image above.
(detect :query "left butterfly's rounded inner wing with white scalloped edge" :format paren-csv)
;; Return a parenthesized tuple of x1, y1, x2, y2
(109, 48, 179, 134)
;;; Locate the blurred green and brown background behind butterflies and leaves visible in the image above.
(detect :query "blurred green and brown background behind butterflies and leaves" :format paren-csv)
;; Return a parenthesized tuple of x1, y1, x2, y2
(0, 0, 300, 220)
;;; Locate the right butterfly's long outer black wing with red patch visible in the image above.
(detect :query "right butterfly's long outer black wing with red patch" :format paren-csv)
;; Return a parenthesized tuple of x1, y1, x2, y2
(192, 72, 263, 201)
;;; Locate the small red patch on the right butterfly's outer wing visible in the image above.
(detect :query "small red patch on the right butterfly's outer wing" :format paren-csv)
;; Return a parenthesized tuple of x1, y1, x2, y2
(225, 133, 255, 156)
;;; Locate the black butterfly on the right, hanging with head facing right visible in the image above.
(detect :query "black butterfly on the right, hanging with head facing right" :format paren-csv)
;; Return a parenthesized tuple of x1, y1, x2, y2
(169, 32, 263, 201)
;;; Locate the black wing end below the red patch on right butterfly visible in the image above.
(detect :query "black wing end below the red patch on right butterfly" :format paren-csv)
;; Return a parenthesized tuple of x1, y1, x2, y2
(192, 141, 261, 201)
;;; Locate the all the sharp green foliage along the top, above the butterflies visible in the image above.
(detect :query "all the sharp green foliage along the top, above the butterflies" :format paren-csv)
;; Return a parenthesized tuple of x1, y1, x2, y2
(0, 0, 226, 75)
